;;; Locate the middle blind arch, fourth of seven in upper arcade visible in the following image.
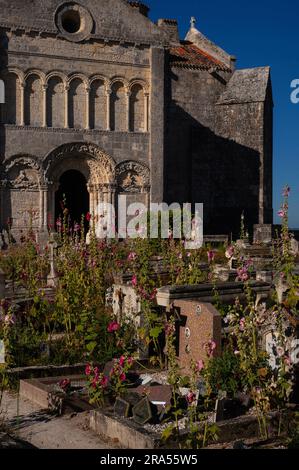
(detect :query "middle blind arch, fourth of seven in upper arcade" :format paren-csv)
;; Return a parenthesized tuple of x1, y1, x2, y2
(69, 78, 86, 129)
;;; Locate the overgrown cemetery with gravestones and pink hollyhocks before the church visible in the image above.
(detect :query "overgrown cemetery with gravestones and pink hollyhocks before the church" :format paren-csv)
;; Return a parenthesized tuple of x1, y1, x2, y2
(0, 188, 299, 449)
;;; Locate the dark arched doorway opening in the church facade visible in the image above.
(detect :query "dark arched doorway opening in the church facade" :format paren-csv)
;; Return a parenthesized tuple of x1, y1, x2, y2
(55, 170, 89, 229)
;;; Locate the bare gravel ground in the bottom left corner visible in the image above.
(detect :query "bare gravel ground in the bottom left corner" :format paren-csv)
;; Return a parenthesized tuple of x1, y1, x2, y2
(1, 393, 116, 449)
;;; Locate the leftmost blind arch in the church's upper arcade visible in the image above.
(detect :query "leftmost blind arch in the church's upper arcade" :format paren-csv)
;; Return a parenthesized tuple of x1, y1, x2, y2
(1, 73, 21, 124)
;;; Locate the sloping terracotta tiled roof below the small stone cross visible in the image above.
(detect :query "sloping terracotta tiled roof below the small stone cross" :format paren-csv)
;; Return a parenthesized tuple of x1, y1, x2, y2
(170, 41, 230, 72)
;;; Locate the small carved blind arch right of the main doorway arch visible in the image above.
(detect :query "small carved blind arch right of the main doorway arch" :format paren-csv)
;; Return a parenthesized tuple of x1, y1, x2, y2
(115, 160, 150, 193)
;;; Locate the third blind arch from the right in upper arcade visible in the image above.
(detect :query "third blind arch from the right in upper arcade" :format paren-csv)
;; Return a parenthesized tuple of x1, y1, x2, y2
(90, 80, 107, 129)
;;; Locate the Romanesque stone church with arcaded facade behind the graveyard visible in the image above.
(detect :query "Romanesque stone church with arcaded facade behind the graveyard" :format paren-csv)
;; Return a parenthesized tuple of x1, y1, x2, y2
(0, 0, 273, 236)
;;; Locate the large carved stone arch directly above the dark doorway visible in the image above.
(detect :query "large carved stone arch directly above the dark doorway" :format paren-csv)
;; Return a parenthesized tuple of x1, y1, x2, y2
(43, 142, 115, 184)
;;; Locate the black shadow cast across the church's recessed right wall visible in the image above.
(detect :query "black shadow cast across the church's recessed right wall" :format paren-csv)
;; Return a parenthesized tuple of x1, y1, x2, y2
(164, 102, 260, 237)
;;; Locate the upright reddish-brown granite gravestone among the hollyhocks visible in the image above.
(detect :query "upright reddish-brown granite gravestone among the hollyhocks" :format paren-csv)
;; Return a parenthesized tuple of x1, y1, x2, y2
(174, 300, 222, 374)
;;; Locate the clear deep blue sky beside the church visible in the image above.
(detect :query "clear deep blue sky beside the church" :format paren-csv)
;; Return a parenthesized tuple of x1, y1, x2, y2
(148, 0, 299, 228)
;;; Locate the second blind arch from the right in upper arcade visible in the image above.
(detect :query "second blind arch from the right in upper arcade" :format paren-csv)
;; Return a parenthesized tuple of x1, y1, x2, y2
(110, 82, 127, 131)
